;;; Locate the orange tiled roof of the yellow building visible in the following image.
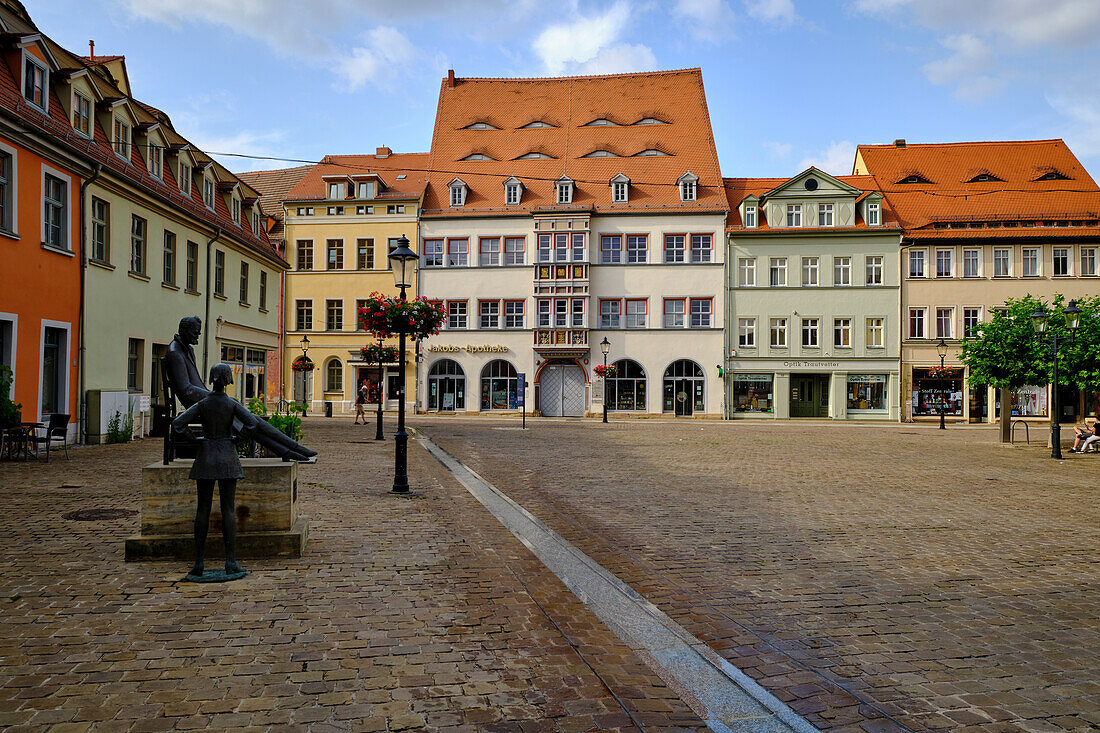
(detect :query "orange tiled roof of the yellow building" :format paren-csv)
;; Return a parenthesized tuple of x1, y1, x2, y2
(283, 153, 428, 201)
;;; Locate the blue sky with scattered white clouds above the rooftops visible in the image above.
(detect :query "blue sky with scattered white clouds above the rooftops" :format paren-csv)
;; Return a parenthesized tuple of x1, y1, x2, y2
(24, 0, 1100, 177)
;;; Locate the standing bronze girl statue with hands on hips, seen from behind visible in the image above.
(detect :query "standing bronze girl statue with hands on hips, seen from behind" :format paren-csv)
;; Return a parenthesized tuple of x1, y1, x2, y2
(172, 364, 259, 582)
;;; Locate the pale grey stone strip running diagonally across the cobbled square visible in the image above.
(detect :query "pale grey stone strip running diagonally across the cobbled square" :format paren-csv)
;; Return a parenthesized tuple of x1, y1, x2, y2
(416, 433, 817, 733)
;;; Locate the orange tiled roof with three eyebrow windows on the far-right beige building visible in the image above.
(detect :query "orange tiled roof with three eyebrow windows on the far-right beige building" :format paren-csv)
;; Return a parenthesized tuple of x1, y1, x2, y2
(856, 140, 1100, 238)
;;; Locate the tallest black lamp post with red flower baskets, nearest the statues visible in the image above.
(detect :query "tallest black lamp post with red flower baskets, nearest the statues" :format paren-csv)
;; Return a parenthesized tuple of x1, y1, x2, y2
(359, 236, 443, 494)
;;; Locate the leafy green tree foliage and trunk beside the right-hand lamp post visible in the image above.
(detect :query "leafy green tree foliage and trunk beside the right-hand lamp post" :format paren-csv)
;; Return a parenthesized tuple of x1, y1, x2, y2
(959, 294, 1100, 442)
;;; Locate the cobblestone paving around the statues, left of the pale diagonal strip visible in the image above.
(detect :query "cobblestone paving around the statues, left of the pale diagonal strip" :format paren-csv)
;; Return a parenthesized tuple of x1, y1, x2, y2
(0, 419, 702, 731)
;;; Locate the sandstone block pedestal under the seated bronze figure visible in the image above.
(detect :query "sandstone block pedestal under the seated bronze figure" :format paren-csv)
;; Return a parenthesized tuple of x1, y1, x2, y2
(125, 458, 308, 559)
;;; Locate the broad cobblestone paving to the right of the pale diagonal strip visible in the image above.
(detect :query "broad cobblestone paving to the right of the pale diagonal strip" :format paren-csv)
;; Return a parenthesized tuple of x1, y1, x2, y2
(416, 418, 1100, 732)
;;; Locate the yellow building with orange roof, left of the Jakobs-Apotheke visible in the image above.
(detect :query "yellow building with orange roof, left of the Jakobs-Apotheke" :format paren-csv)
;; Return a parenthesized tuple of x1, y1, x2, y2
(283, 147, 428, 415)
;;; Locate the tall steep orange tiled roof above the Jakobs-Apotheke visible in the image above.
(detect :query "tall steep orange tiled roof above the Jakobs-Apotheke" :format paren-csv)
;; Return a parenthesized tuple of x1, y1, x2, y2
(424, 68, 726, 216)
